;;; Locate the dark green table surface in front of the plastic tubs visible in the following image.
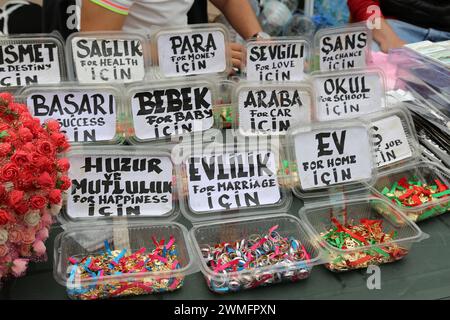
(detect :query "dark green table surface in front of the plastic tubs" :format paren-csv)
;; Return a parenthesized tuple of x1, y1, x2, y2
(0, 199, 450, 300)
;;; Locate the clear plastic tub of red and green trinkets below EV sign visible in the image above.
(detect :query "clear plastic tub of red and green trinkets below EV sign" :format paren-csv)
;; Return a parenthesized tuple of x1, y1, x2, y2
(299, 197, 428, 272)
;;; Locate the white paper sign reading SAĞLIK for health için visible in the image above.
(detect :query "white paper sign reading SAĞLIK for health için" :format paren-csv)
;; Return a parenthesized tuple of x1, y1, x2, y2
(72, 37, 145, 83)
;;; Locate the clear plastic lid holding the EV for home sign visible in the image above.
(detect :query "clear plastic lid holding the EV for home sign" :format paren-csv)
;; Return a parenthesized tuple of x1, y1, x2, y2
(286, 119, 377, 199)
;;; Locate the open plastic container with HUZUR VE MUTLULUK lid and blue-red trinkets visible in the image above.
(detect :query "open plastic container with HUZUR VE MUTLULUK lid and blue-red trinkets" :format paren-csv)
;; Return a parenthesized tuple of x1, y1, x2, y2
(54, 146, 198, 300)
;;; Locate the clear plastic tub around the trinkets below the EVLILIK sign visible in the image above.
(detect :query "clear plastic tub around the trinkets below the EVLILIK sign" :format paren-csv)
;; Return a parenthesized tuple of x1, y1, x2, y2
(190, 214, 320, 293)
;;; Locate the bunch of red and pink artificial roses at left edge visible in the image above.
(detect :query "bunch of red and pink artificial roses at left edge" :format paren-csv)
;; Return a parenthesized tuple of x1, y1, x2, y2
(0, 93, 70, 281)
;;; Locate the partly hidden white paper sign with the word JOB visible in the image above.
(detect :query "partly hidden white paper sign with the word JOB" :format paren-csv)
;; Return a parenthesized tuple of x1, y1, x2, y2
(373, 116, 412, 167)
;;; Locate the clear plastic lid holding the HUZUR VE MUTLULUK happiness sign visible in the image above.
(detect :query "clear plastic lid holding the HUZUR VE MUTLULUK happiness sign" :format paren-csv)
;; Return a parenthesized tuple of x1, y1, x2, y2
(58, 146, 179, 226)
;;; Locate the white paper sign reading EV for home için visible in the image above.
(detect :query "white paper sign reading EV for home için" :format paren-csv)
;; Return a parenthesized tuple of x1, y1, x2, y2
(294, 127, 372, 190)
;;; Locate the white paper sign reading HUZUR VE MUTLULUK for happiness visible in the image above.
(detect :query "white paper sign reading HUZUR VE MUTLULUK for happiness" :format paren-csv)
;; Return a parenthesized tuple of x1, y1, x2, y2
(67, 155, 172, 218)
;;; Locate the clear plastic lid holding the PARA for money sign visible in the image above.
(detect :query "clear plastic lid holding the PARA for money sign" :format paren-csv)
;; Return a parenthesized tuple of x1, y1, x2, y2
(151, 23, 231, 78)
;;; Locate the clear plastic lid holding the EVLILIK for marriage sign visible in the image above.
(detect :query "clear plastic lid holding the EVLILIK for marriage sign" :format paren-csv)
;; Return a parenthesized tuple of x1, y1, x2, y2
(174, 143, 292, 223)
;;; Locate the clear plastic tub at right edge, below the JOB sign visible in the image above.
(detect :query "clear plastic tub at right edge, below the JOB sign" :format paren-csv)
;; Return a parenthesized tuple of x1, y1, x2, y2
(371, 161, 450, 221)
